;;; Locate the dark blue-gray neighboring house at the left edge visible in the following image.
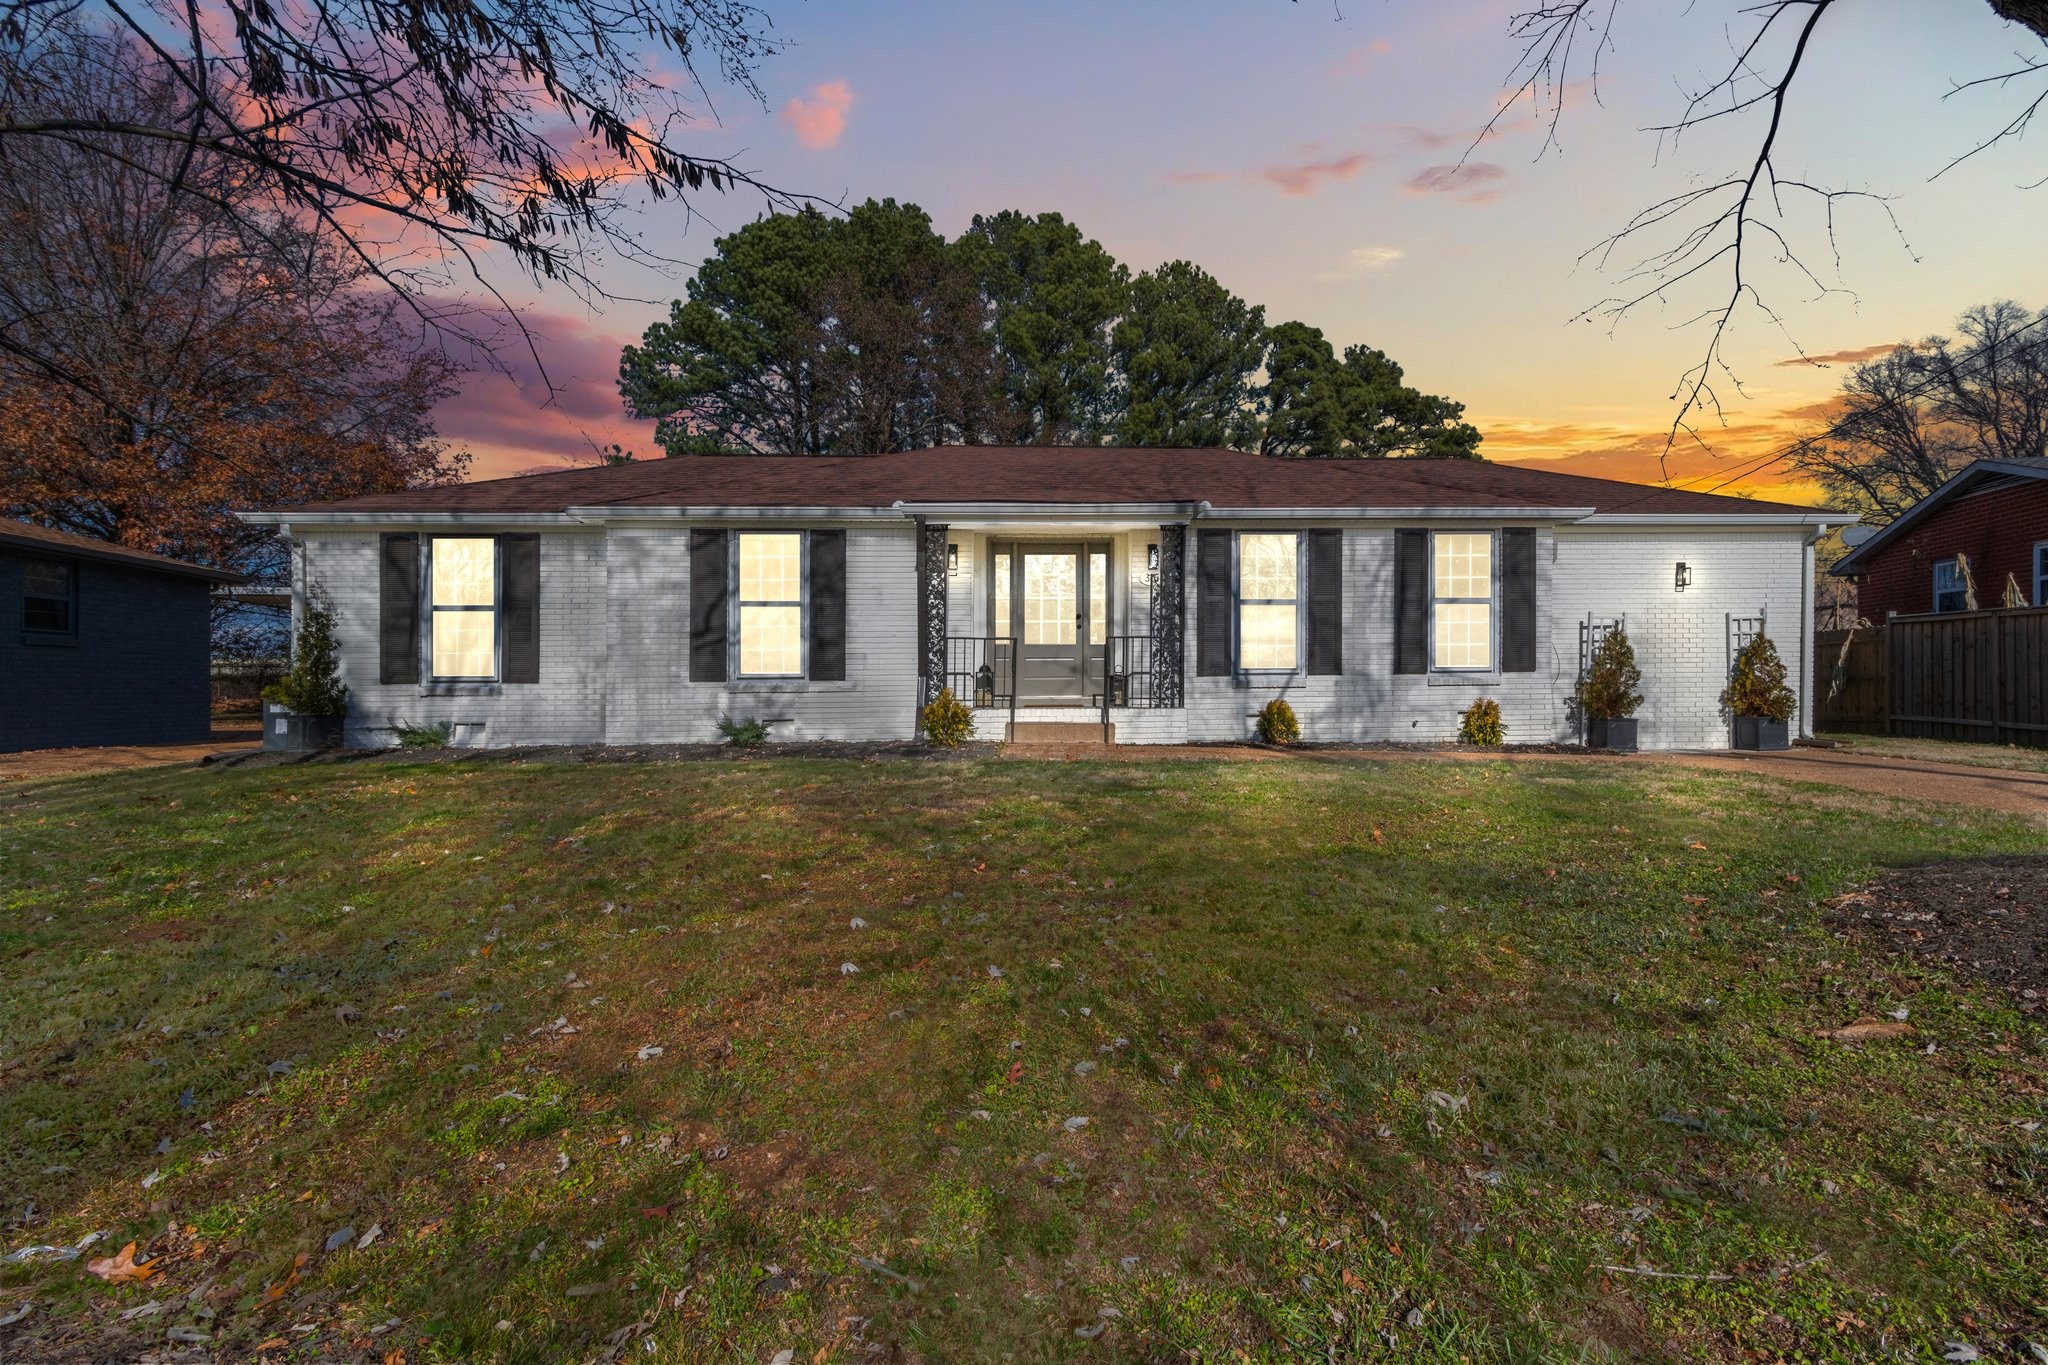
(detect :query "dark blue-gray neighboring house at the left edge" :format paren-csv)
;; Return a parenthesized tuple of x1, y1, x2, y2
(0, 520, 240, 753)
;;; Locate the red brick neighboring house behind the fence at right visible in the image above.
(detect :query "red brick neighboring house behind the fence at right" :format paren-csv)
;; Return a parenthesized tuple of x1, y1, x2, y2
(1831, 460, 2048, 624)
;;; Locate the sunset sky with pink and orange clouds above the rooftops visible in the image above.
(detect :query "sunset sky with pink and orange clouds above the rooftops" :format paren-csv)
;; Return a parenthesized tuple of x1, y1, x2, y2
(440, 0, 2048, 501)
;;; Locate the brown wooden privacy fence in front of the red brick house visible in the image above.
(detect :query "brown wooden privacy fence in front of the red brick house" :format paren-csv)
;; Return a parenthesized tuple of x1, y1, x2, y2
(1812, 608, 2048, 747)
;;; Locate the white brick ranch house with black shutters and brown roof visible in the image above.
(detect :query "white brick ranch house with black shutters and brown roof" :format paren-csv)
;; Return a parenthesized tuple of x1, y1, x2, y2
(246, 446, 1849, 749)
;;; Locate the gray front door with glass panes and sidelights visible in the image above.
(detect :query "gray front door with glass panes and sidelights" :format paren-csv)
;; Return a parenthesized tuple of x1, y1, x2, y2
(993, 542, 1110, 704)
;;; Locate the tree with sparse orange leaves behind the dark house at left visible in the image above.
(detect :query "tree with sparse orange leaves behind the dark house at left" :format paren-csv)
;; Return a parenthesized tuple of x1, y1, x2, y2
(0, 31, 467, 626)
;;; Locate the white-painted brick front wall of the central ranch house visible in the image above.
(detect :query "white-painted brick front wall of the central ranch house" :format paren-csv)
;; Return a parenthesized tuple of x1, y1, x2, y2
(301, 524, 1810, 749)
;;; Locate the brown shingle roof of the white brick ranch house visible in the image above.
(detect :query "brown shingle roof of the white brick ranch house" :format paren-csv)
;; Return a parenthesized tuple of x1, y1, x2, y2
(280, 446, 1812, 516)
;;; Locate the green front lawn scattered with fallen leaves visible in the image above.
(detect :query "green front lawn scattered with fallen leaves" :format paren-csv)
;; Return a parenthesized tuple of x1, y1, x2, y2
(0, 759, 2048, 1365)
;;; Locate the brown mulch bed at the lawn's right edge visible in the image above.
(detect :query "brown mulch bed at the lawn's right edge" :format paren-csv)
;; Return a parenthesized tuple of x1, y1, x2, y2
(1829, 857, 2048, 1011)
